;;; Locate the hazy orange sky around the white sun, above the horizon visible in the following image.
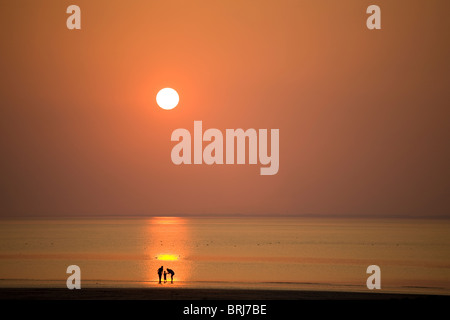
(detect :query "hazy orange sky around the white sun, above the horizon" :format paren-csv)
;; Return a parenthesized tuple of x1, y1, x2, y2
(0, 0, 450, 217)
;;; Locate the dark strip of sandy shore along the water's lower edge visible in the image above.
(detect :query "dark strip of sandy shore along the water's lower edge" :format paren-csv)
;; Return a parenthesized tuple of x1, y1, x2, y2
(0, 288, 440, 300)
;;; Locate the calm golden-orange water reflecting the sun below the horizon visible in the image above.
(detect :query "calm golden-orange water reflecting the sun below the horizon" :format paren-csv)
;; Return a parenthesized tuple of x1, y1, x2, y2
(0, 218, 450, 295)
